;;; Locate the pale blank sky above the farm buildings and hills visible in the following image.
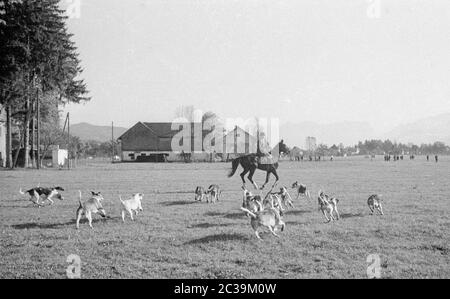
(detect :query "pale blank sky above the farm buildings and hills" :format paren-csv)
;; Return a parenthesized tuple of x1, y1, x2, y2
(62, 0, 450, 131)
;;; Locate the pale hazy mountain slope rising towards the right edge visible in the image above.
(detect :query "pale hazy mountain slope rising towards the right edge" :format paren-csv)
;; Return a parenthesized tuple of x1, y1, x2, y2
(386, 113, 450, 144)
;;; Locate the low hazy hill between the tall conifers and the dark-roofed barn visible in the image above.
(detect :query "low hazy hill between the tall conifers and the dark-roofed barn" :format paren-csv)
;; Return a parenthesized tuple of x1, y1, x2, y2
(70, 123, 128, 142)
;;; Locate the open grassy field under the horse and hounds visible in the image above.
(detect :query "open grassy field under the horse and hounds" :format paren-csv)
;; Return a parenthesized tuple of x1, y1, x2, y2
(0, 157, 450, 278)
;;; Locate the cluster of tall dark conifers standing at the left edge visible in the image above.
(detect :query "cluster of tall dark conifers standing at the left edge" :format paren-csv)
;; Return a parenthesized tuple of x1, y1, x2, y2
(0, 0, 90, 168)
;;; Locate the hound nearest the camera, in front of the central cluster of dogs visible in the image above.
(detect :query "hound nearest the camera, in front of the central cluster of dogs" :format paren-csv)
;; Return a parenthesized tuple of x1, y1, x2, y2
(241, 208, 286, 240)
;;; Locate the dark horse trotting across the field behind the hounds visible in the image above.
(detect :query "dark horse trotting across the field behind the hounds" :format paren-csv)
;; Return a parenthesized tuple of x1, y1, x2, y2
(228, 154, 280, 189)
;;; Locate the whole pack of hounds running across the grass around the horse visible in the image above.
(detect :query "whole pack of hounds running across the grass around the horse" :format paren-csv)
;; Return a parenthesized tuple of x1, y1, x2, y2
(19, 182, 383, 239)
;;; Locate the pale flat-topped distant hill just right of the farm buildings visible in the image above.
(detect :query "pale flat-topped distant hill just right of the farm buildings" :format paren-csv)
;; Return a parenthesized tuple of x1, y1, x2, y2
(280, 122, 375, 148)
